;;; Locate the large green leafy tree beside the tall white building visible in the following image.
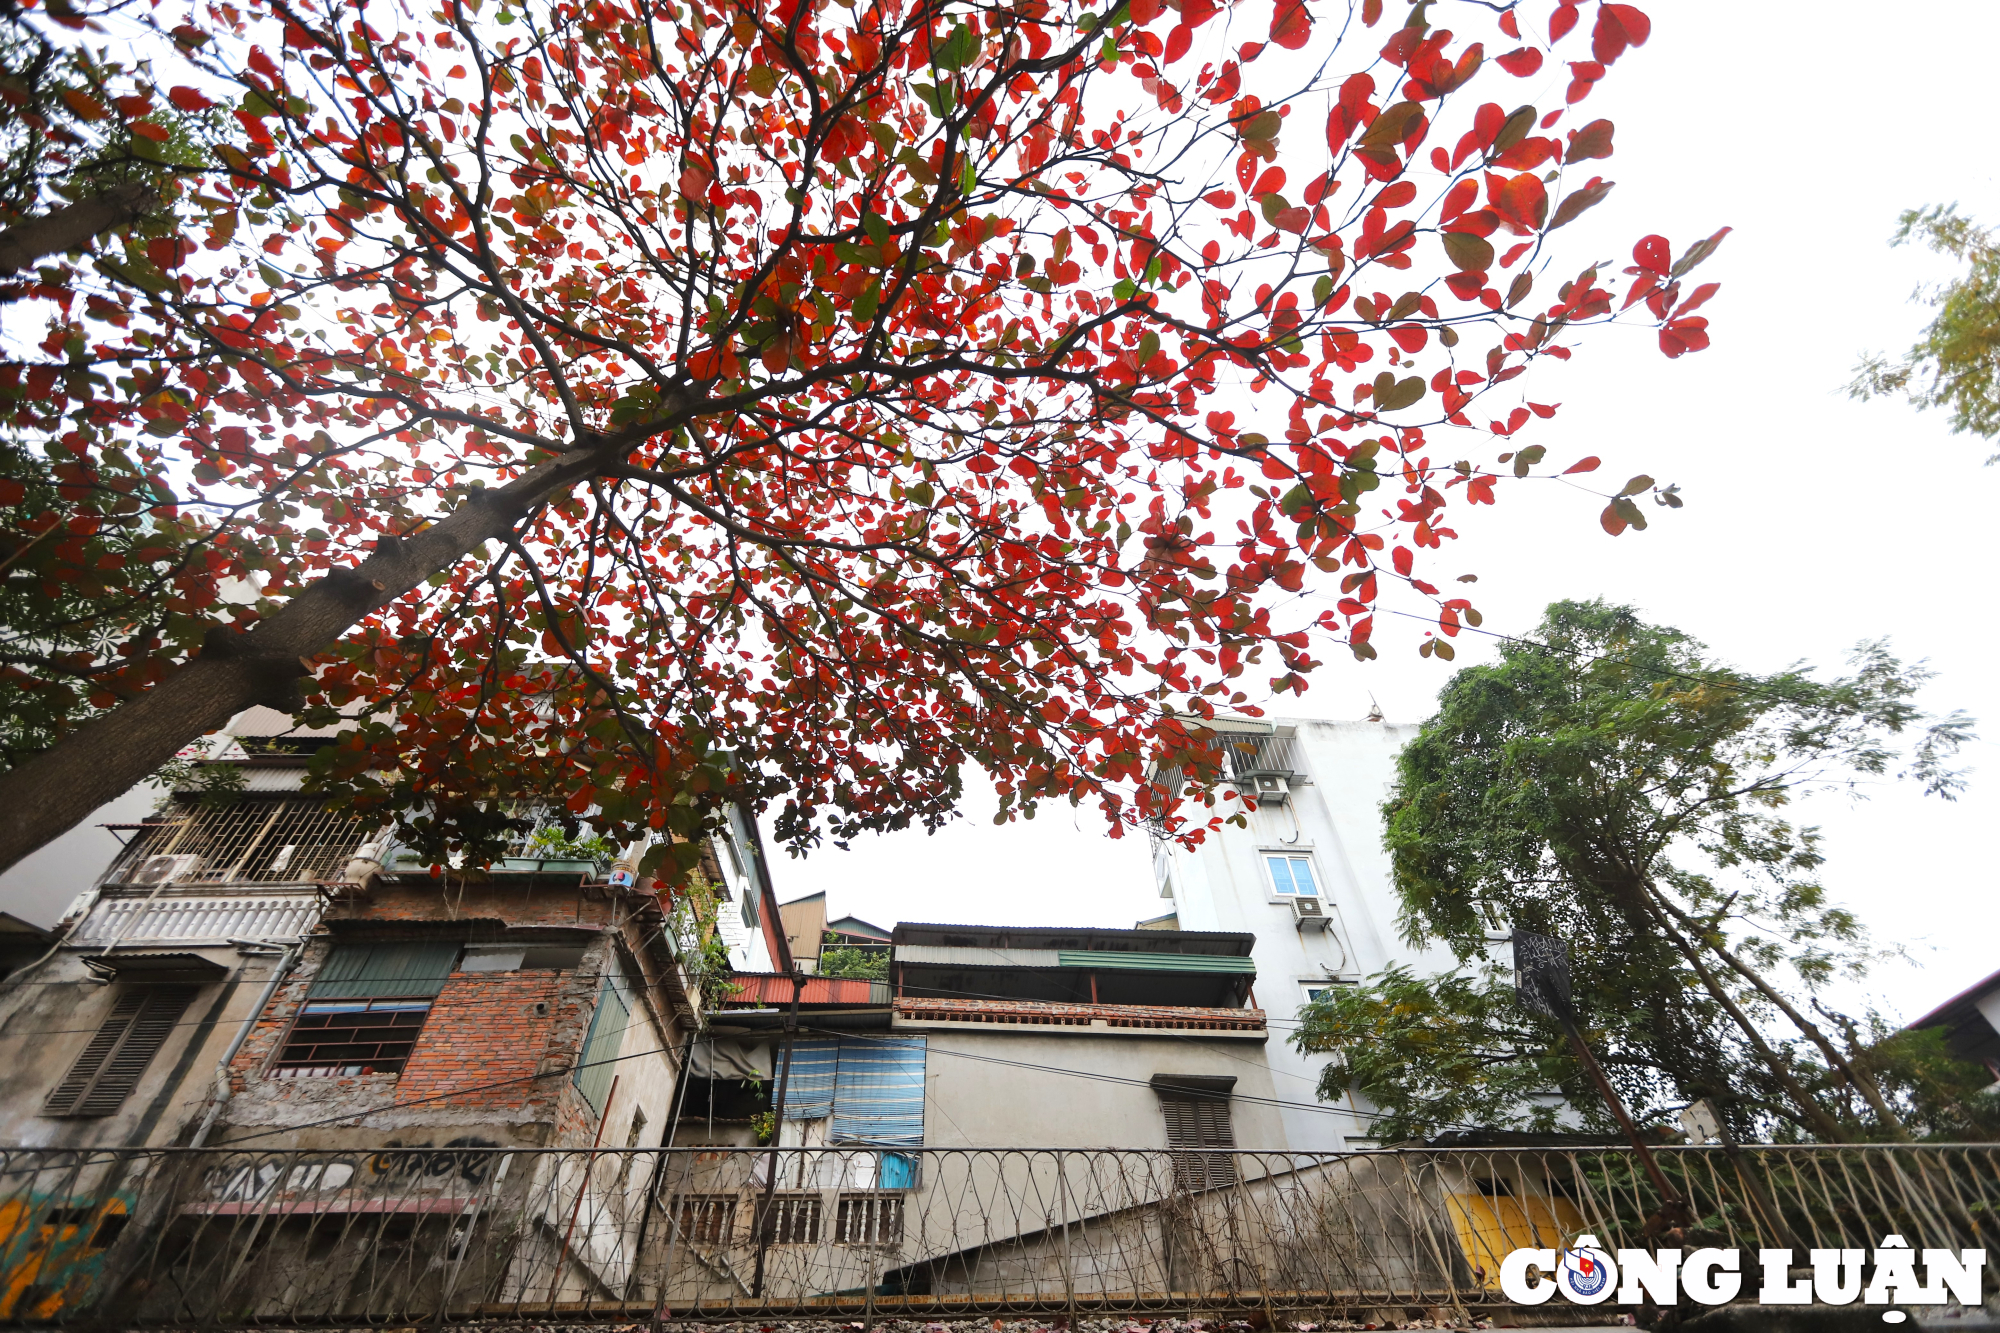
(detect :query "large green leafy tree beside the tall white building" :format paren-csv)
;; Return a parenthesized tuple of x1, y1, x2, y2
(1294, 602, 1970, 1141)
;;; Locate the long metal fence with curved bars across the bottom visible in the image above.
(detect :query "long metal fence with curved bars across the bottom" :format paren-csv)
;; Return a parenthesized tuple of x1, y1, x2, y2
(0, 1147, 2000, 1329)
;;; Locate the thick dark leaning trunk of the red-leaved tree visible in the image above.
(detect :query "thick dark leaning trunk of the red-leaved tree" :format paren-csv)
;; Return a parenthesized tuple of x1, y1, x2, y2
(0, 450, 604, 871)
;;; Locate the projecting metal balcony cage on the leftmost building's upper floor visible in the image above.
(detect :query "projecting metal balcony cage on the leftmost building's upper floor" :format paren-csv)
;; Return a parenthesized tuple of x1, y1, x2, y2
(112, 797, 368, 885)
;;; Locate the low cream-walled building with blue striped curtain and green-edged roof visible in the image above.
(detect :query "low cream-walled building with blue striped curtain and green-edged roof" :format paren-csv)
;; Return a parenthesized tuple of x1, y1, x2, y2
(662, 923, 1284, 1295)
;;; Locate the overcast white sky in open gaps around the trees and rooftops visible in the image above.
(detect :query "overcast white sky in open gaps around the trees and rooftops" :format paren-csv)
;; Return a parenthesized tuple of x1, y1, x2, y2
(778, 0, 2000, 1017)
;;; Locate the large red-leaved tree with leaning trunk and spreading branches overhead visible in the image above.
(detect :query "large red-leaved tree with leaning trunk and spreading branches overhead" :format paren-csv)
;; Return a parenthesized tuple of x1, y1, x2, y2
(0, 0, 1720, 863)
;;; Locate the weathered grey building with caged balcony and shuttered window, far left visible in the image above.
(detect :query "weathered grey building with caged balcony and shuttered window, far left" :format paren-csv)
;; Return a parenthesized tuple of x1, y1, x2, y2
(0, 709, 356, 1147)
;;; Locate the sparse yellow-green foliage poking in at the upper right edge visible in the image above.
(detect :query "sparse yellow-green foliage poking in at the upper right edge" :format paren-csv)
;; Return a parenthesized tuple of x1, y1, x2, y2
(1848, 204, 2000, 464)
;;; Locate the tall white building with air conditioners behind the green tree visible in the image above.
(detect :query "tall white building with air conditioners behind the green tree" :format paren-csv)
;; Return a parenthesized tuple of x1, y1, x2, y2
(1142, 719, 1452, 1151)
